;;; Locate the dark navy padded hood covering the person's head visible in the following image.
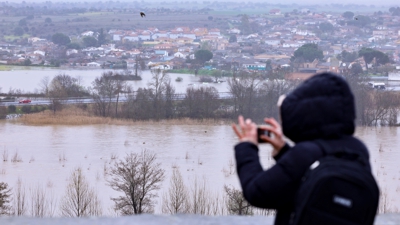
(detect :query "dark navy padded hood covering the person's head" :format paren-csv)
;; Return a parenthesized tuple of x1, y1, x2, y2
(280, 73, 355, 142)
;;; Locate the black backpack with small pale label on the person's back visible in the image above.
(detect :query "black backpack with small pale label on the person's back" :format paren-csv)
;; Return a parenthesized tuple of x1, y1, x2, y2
(289, 140, 379, 225)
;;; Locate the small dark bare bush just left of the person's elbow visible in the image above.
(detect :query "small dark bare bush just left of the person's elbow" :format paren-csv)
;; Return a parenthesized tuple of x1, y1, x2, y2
(224, 185, 253, 215)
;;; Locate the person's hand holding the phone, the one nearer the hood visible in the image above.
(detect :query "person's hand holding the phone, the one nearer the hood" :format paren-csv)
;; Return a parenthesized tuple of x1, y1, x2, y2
(260, 118, 286, 156)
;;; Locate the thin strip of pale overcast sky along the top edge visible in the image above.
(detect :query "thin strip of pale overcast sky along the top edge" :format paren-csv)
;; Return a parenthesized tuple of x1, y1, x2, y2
(9, 0, 400, 6)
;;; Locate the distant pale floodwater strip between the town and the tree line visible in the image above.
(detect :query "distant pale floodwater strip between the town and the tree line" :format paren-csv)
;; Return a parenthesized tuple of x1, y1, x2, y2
(0, 68, 228, 93)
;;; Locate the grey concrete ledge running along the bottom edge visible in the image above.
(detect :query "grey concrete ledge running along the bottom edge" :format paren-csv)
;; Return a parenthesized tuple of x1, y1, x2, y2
(0, 214, 400, 225)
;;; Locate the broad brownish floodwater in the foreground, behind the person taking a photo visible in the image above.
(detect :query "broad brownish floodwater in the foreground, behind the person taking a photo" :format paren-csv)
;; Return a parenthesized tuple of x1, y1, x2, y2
(0, 121, 400, 215)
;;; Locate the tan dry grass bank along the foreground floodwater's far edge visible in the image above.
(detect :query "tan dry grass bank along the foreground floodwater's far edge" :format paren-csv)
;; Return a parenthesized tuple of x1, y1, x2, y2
(12, 106, 232, 126)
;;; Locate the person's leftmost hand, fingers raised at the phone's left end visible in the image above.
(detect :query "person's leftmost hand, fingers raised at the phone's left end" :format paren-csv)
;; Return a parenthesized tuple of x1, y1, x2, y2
(232, 116, 258, 145)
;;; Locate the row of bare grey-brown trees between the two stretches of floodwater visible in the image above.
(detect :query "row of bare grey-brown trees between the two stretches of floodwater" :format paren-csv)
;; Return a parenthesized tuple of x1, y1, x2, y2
(0, 68, 400, 126)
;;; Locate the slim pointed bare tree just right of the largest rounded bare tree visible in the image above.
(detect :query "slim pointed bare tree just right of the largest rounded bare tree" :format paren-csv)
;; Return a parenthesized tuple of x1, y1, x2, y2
(162, 168, 190, 214)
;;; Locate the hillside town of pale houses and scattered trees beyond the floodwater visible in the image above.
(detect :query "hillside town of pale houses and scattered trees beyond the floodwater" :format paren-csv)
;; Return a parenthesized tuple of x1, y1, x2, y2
(0, 2, 400, 80)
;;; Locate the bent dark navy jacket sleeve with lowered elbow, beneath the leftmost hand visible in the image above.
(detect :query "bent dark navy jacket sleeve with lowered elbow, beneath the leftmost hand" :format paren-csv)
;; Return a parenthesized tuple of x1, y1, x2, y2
(235, 142, 322, 209)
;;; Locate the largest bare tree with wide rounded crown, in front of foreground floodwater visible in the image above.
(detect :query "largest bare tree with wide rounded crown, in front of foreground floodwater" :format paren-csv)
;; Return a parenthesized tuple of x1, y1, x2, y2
(108, 150, 164, 215)
